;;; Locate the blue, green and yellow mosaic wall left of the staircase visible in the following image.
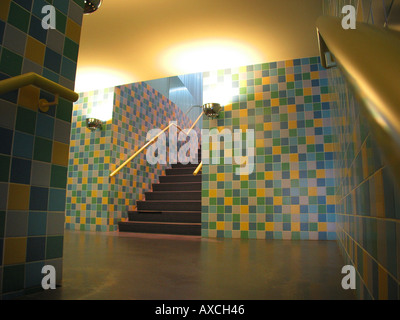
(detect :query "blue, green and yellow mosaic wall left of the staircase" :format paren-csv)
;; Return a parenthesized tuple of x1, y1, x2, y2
(66, 82, 198, 231)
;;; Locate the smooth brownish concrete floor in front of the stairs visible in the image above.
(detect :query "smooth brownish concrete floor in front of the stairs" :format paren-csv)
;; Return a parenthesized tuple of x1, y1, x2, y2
(24, 230, 355, 300)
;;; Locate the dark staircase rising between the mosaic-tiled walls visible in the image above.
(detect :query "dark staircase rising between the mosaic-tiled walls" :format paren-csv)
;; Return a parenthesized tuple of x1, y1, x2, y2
(118, 151, 201, 236)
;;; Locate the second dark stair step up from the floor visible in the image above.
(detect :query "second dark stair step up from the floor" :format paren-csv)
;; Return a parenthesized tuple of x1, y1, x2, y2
(128, 211, 201, 223)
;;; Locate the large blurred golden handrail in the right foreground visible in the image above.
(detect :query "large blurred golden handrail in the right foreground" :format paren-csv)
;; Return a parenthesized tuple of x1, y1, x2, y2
(317, 16, 400, 181)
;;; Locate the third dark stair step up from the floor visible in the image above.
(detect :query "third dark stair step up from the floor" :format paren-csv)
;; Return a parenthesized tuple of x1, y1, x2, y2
(136, 200, 201, 211)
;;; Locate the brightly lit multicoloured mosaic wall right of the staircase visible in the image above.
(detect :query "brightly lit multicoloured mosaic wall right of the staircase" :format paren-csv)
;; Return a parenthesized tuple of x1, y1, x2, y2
(202, 57, 336, 240)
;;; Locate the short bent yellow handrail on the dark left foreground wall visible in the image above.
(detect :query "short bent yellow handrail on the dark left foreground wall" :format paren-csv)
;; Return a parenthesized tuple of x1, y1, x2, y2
(0, 72, 79, 102)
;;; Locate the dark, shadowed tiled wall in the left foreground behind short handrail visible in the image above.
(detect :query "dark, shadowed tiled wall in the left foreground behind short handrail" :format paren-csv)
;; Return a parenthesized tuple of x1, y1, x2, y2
(0, 0, 83, 299)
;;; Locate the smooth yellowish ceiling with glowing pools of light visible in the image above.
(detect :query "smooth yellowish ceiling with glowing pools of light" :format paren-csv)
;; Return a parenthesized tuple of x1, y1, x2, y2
(75, 0, 322, 92)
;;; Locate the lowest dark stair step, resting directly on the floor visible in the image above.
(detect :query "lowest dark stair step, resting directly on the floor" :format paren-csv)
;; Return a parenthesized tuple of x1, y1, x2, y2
(118, 221, 201, 236)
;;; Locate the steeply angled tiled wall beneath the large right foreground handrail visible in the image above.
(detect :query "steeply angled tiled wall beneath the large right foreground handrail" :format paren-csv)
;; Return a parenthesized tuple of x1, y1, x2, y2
(325, 1, 400, 299)
